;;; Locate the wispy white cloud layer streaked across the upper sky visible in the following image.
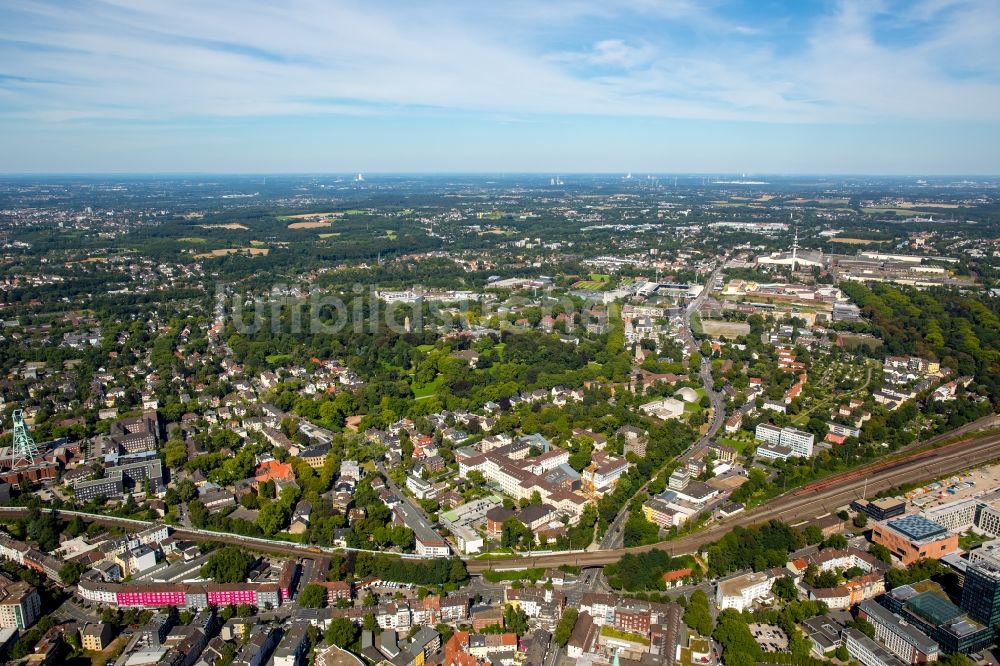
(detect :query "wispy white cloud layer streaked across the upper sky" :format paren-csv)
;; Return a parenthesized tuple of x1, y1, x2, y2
(0, 0, 1000, 122)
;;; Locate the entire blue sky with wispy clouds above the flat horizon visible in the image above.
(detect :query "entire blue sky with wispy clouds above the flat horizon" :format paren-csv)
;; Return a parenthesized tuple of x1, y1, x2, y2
(0, 0, 1000, 174)
